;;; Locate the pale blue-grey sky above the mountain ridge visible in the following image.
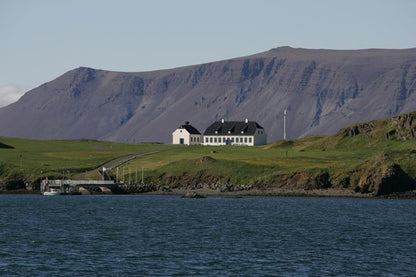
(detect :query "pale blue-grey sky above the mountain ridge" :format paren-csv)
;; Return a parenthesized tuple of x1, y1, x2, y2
(0, 0, 416, 107)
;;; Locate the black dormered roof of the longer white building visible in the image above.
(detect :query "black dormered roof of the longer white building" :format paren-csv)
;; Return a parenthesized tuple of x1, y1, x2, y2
(204, 121, 264, 136)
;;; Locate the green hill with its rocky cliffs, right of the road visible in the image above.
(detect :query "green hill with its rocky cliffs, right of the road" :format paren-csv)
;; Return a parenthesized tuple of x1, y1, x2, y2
(114, 110, 416, 194)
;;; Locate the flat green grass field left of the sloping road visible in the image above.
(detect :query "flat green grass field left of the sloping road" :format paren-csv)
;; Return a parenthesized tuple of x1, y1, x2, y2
(0, 137, 171, 181)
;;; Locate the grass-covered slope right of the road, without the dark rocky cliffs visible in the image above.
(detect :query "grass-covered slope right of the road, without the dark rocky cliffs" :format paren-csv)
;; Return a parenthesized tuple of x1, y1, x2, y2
(115, 135, 416, 184)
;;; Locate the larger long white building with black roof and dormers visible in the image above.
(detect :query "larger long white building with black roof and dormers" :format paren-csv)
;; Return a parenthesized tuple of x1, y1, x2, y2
(203, 119, 267, 146)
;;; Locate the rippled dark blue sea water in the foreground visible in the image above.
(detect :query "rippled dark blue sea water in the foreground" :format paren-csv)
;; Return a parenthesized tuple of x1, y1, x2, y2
(0, 195, 416, 276)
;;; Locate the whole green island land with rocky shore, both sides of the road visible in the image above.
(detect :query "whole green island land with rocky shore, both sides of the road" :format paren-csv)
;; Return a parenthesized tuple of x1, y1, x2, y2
(0, 110, 416, 194)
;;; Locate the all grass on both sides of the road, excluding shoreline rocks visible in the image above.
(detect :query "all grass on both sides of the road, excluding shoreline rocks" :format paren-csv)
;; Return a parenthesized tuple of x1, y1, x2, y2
(0, 110, 416, 188)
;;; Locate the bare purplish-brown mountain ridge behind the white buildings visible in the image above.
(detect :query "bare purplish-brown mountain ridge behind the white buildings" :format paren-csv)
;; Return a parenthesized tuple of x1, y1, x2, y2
(0, 47, 416, 142)
